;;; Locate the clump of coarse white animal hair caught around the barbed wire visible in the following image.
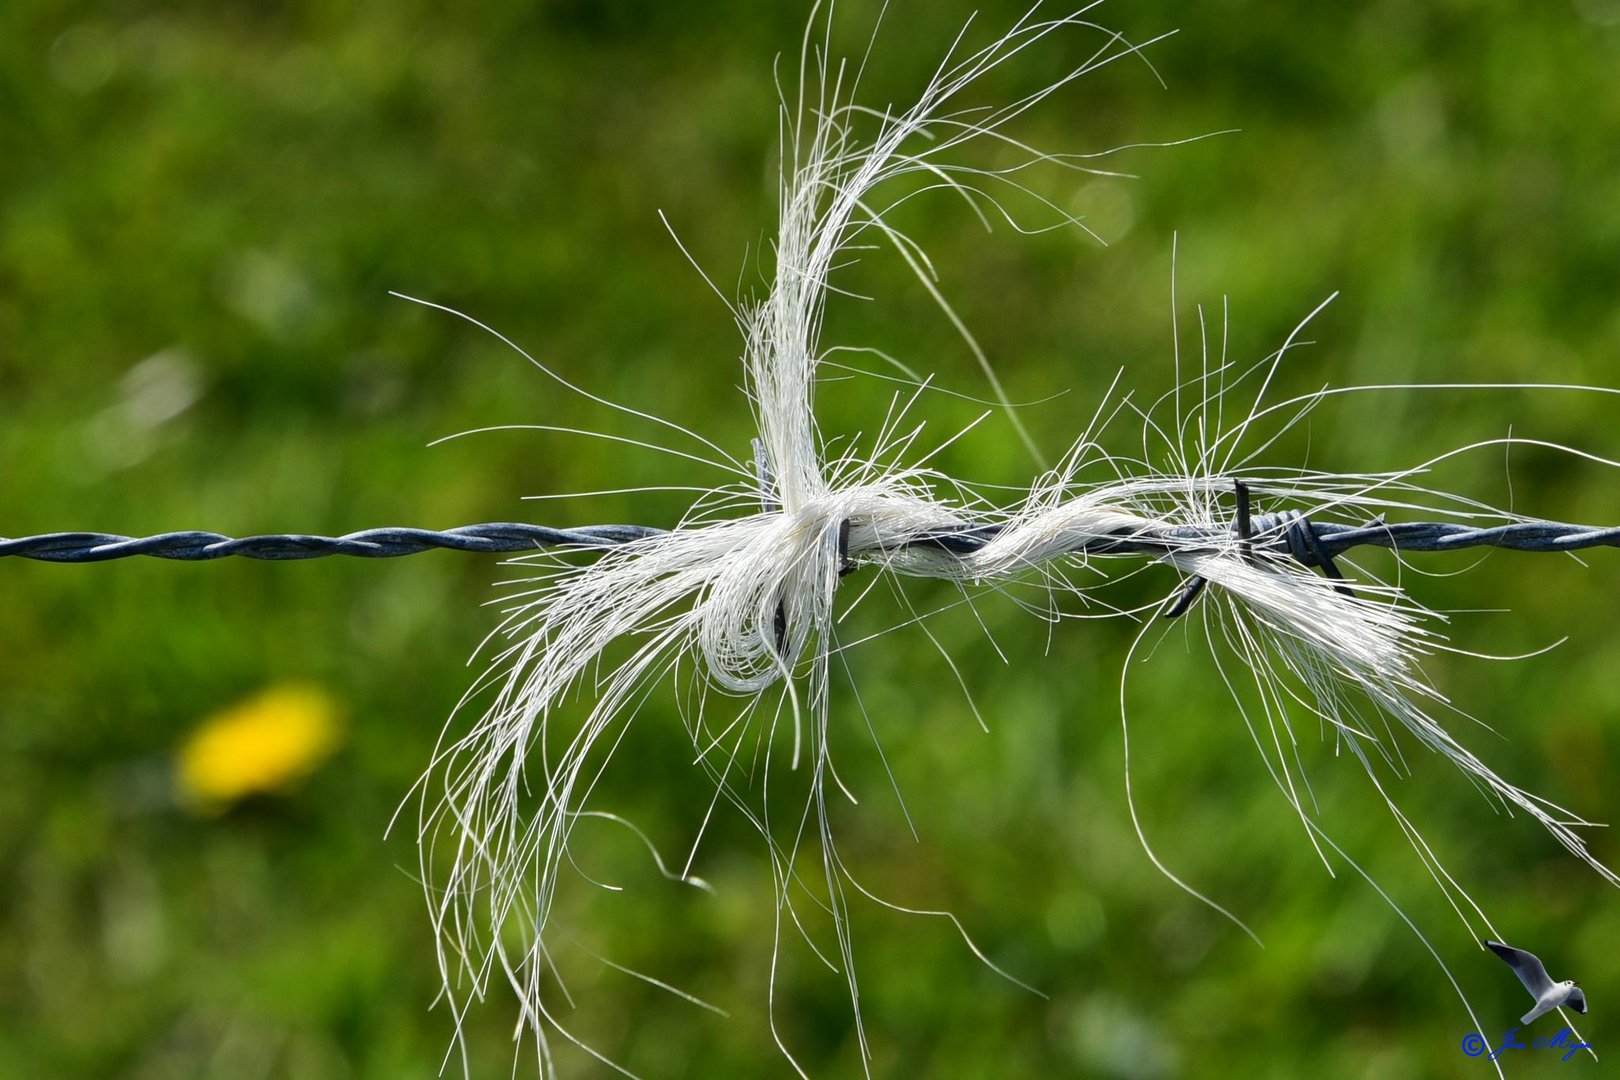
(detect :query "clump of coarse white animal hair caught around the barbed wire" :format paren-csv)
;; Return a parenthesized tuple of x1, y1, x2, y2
(408, 6, 1612, 1061)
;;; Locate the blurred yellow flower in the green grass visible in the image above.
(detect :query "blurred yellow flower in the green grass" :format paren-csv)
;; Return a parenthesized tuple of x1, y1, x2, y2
(177, 683, 340, 813)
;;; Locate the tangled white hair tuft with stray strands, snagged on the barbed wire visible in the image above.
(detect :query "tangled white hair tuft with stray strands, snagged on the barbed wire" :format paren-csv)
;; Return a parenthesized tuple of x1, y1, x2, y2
(408, 11, 1617, 1069)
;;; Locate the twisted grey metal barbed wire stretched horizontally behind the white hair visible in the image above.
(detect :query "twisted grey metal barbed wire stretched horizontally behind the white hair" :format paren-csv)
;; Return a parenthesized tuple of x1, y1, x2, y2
(0, 512, 1620, 566)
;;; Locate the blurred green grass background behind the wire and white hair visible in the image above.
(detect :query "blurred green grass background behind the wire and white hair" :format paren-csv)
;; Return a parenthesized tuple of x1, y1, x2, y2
(0, 0, 1620, 1080)
